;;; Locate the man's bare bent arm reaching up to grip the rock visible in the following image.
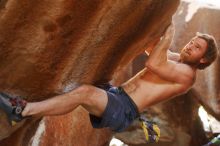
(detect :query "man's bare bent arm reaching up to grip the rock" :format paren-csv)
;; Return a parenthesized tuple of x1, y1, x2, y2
(145, 28, 194, 85)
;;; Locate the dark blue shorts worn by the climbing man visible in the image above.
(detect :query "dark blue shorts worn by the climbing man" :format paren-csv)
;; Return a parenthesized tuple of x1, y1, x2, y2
(90, 86, 139, 132)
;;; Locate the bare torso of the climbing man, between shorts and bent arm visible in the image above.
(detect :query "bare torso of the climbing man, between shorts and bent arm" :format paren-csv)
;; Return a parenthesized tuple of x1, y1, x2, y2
(122, 69, 186, 112)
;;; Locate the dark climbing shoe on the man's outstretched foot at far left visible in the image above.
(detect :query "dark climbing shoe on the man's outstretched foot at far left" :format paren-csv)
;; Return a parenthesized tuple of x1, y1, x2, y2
(0, 92, 27, 126)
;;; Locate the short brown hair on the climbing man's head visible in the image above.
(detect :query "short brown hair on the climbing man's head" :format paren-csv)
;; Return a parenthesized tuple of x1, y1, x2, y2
(196, 32, 218, 69)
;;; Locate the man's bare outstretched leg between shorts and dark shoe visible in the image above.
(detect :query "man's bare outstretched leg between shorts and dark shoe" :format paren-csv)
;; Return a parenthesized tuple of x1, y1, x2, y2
(22, 85, 108, 117)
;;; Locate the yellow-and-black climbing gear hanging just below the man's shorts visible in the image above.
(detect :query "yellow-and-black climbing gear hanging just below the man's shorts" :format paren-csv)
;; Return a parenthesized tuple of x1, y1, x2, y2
(139, 116, 160, 143)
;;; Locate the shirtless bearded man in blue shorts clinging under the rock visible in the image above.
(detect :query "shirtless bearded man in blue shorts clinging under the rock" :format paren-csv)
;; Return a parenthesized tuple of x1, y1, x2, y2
(0, 28, 218, 135)
